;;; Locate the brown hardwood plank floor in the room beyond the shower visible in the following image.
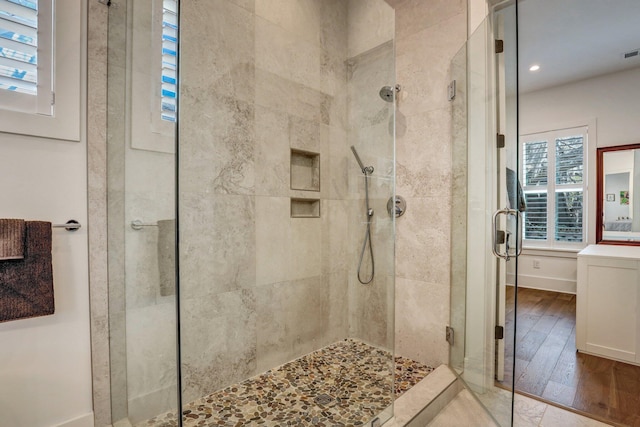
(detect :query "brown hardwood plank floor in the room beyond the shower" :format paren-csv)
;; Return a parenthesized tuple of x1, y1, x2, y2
(501, 287, 640, 427)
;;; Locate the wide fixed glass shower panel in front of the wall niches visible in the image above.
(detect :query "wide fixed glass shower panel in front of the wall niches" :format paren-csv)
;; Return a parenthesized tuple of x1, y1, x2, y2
(178, 0, 395, 425)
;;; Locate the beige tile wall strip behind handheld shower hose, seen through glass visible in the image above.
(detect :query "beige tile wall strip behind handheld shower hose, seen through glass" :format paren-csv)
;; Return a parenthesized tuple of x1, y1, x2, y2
(346, 30, 395, 348)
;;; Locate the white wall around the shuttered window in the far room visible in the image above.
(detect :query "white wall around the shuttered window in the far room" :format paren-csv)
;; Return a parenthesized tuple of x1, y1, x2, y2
(509, 68, 640, 293)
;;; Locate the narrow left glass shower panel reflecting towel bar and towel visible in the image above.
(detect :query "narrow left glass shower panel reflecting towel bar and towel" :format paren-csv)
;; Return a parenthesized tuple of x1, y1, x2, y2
(107, 0, 178, 426)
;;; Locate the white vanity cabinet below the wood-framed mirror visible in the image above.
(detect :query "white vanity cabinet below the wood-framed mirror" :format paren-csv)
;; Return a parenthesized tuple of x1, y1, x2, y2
(576, 245, 640, 365)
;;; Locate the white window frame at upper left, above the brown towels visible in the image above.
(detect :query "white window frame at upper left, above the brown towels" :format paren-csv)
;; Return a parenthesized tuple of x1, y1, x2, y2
(0, 0, 83, 141)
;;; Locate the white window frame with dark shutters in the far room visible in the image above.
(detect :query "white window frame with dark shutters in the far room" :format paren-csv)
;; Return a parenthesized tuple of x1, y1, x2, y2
(518, 125, 593, 250)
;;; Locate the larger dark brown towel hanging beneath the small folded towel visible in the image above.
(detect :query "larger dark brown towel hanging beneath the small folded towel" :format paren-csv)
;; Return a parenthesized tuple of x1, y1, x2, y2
(0, 221, 54, 322)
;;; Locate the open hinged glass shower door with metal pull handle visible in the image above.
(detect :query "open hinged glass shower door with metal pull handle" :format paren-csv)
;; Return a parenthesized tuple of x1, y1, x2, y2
(450, 2, 521, 426)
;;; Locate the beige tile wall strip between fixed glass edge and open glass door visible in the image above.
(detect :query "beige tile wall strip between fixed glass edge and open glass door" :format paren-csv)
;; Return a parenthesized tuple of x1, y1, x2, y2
(389, 0, 467, 366)
